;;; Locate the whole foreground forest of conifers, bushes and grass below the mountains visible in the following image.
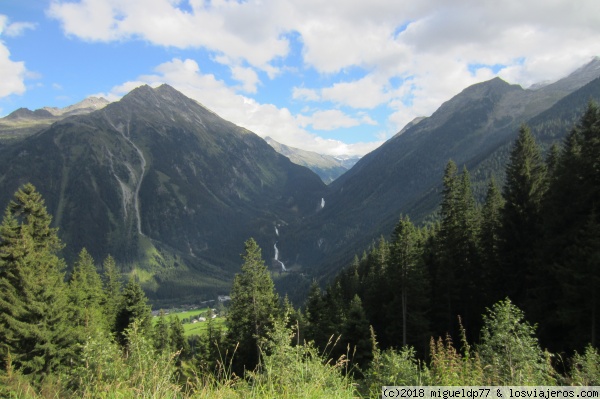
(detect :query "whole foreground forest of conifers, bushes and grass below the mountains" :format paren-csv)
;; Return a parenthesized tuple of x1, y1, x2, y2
(0, 103, 600, 398)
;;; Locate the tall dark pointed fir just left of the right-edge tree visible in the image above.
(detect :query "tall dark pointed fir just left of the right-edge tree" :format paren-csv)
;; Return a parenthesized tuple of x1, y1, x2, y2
(495, 126, 547, 303)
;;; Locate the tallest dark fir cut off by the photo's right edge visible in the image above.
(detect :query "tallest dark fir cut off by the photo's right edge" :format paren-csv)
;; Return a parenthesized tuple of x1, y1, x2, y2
(540, 102, 600, 349)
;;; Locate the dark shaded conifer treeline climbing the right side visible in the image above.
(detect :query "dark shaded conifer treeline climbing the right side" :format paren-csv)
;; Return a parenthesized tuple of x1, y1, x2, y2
(306, 103, 600, 357)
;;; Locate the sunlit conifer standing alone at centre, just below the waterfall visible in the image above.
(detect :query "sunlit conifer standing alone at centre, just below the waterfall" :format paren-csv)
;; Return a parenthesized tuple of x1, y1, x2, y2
(227, 238, 279, 372)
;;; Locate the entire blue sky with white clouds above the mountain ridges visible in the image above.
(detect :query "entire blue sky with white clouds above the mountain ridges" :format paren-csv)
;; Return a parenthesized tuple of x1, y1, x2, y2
(0, 0, 600, 155)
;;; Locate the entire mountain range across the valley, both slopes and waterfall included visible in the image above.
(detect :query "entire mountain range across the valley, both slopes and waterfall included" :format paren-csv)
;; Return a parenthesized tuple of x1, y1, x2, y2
(0, 59, 600, 300)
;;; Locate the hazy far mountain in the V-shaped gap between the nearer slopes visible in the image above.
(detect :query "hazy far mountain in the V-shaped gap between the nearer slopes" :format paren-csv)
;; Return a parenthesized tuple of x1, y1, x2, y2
(265, 137, 360, 184)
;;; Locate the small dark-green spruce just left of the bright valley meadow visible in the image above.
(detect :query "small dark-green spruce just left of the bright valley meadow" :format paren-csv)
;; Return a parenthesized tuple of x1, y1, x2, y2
(115, 278, 152, 345)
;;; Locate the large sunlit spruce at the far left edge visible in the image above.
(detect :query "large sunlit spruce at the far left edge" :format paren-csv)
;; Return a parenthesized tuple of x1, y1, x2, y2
(0, 184, 73, 377)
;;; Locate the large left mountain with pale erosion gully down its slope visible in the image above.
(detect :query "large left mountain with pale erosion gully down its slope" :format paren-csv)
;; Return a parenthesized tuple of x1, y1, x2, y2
(0, 85, 326, 299)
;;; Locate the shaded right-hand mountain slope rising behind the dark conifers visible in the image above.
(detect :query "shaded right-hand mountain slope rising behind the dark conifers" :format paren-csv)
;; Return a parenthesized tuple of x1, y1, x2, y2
(280, 58, 600, 276)
